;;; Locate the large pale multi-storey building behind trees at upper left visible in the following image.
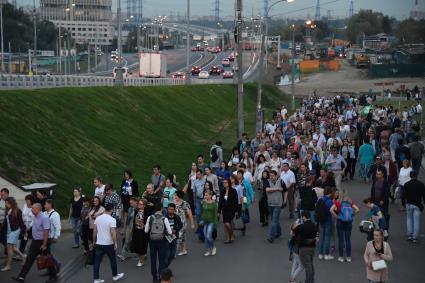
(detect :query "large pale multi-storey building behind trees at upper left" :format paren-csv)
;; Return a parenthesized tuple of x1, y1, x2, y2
(40, 0, 114, 46)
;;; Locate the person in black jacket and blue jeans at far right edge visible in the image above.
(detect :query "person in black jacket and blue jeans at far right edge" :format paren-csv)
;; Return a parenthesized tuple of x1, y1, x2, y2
(403, 171, 425, 243)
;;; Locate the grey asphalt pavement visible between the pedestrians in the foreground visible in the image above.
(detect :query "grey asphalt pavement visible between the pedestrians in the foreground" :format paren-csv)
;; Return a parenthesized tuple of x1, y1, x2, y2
(1, 172, 425, 283)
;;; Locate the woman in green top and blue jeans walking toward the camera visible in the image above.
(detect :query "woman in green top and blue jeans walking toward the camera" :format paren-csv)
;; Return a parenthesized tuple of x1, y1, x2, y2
(202, 189, 218, 256)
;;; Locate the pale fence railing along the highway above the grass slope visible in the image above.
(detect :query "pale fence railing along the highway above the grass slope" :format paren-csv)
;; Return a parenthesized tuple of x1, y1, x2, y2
(0, 74, 184, 89)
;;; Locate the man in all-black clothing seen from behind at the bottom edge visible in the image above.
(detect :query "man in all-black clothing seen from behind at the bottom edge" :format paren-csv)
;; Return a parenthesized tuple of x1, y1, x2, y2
(294, 211, 317, 283)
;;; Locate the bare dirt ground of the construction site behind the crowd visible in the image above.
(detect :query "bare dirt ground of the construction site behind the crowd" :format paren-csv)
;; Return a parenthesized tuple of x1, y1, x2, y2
(280, 60, 425, 95)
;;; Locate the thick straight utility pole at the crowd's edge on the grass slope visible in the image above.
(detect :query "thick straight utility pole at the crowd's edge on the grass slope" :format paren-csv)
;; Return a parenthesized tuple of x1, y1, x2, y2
(236, 0, 245, 139)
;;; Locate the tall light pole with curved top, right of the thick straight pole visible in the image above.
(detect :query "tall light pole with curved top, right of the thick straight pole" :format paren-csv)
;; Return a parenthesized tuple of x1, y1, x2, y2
(255, 0, 294, 132)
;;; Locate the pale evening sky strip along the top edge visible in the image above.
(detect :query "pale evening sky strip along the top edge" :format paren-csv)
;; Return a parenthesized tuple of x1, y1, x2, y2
(17, 0, 425, 20)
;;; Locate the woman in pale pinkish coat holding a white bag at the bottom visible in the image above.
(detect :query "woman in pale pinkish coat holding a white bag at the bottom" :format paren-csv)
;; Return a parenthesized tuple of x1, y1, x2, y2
(363, 229, 393, 283)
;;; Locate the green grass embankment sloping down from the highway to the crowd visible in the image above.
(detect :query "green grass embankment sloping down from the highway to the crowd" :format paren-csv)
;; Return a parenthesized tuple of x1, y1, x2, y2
(0, 85, 290, 211)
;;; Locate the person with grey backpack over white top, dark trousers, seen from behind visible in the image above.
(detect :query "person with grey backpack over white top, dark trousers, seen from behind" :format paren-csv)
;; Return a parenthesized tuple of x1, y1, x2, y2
(145, 203, 173, 282)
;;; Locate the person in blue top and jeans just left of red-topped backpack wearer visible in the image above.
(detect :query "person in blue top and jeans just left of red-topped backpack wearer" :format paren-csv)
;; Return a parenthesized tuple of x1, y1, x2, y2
(315, 187, 335, 260)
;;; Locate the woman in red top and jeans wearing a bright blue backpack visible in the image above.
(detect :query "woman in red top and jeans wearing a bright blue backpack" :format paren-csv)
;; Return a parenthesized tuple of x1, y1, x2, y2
(331, 191, 360, 262)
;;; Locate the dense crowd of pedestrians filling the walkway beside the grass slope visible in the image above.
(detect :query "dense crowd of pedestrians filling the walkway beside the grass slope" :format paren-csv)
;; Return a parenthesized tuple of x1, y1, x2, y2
(0, 91, 425, 283)
